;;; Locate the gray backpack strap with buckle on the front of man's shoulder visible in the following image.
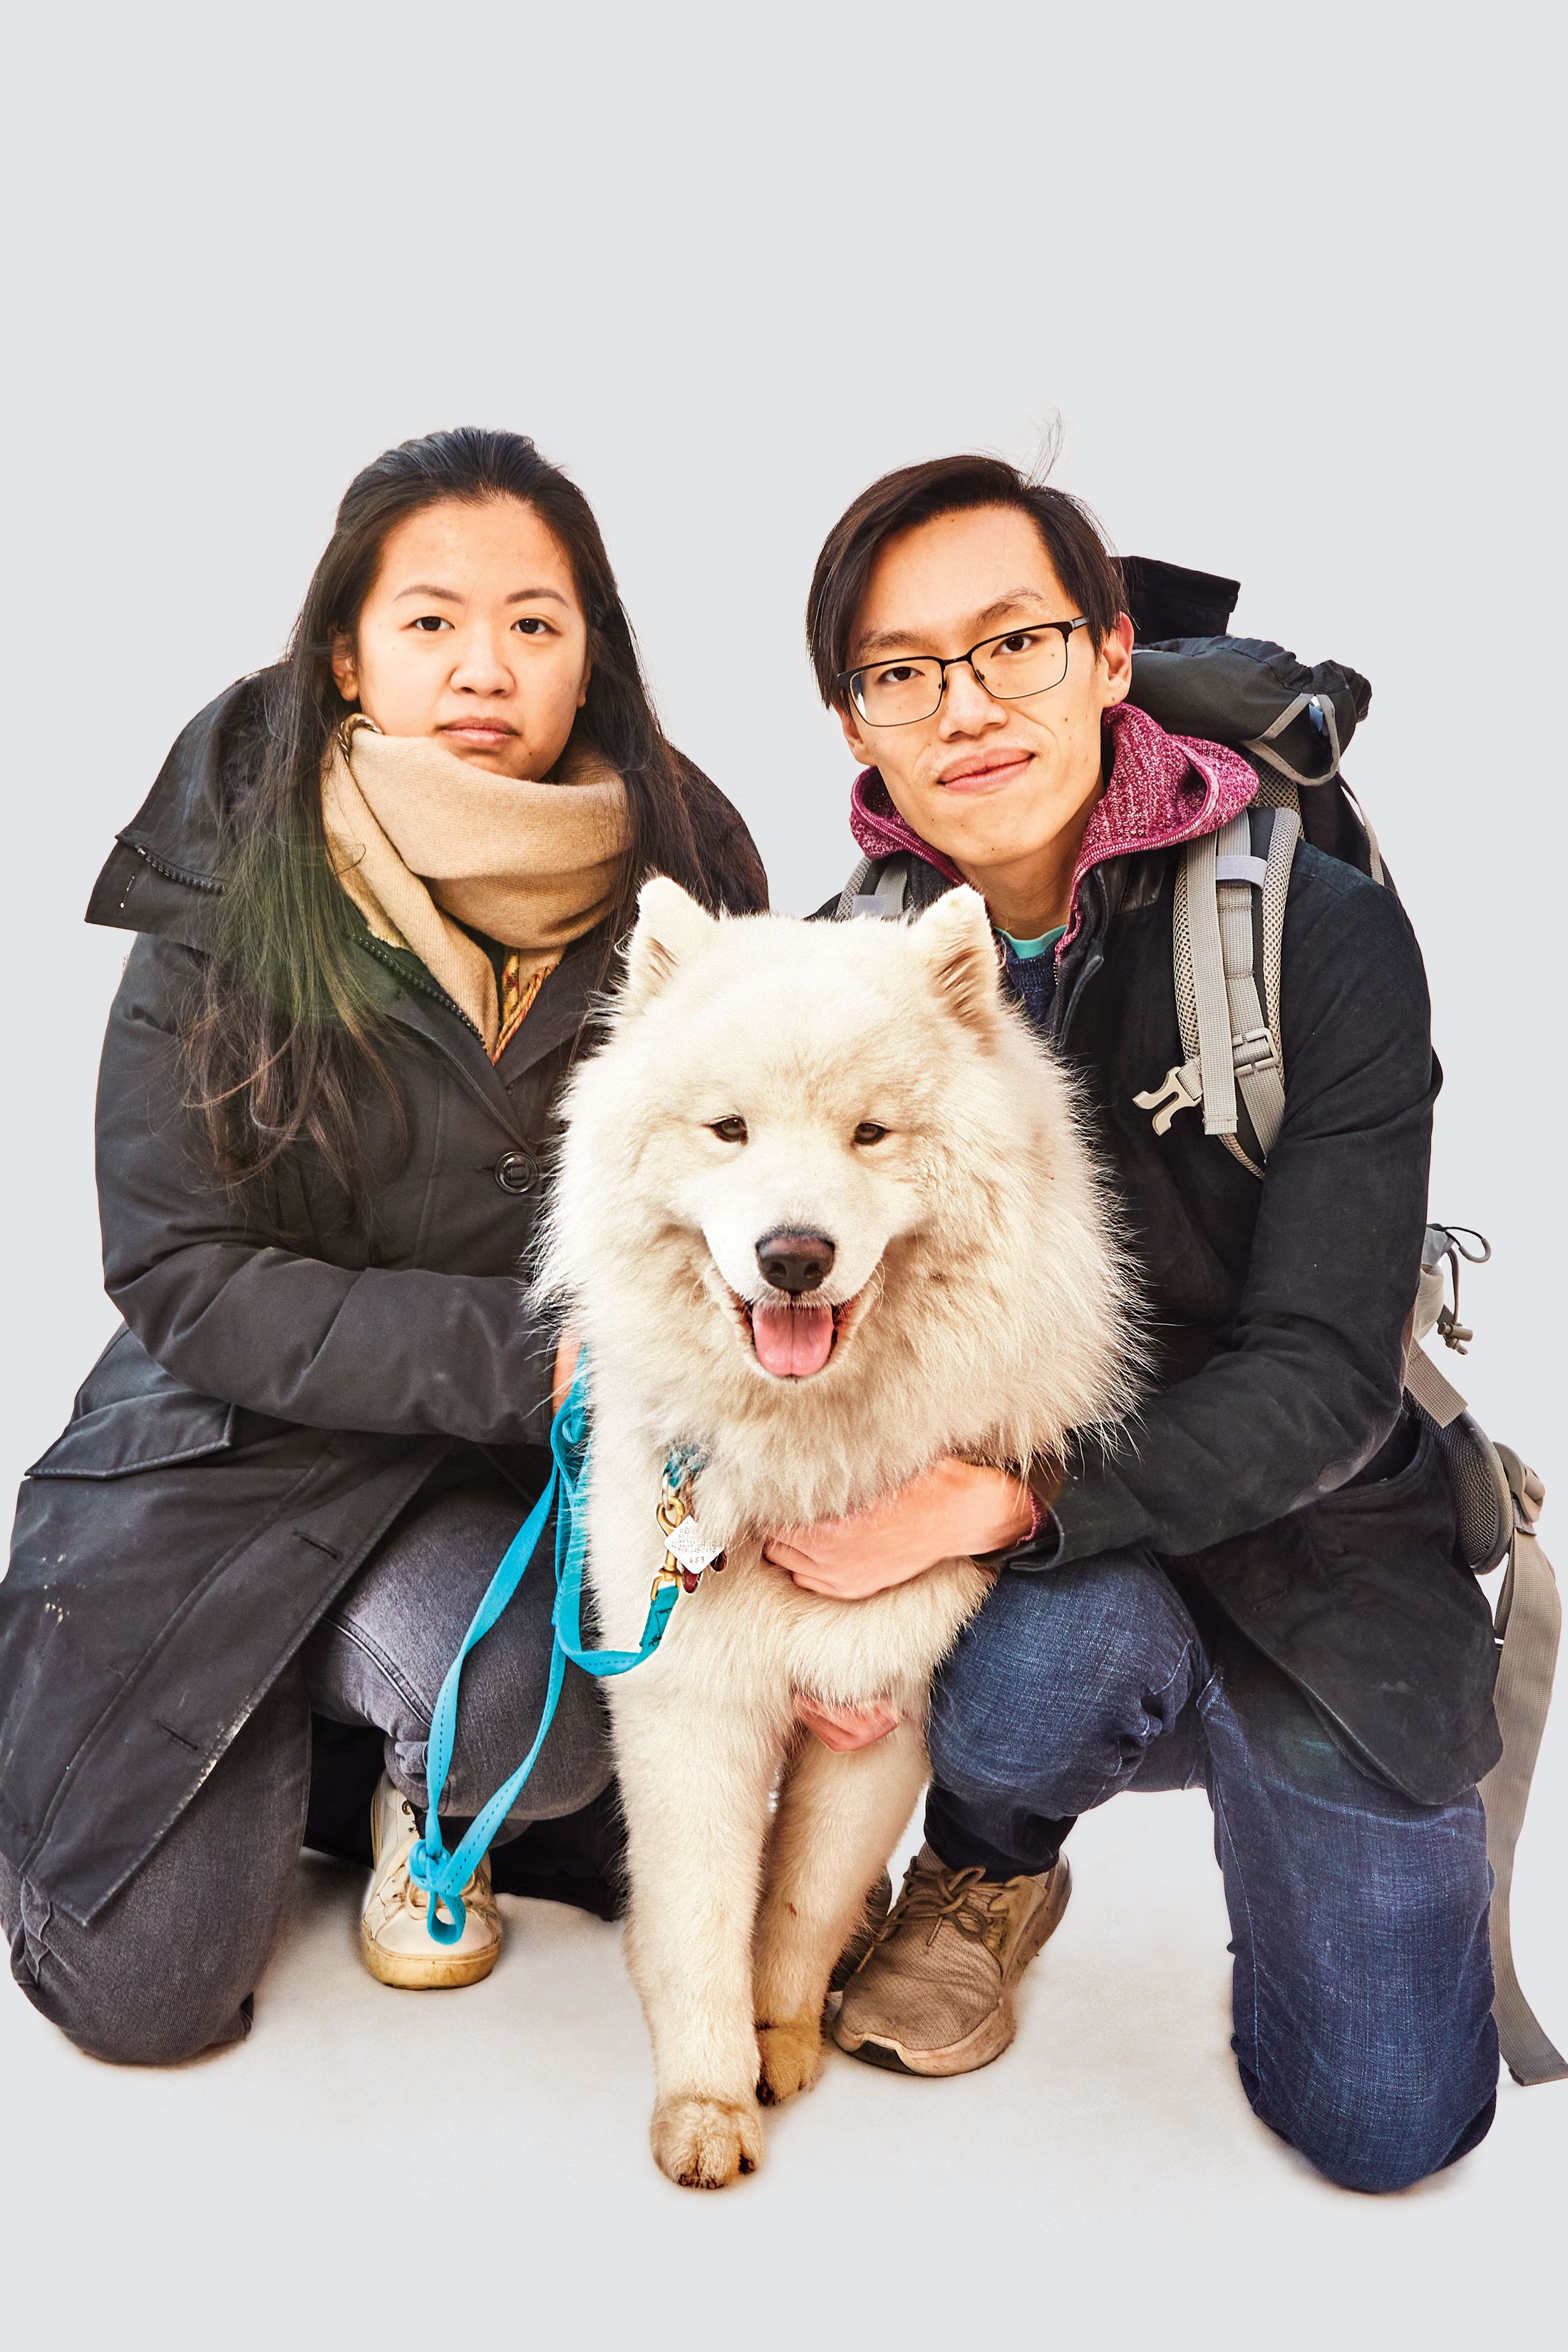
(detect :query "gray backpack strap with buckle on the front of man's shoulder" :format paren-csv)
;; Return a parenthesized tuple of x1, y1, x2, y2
(1133, 807, 1300, 1176)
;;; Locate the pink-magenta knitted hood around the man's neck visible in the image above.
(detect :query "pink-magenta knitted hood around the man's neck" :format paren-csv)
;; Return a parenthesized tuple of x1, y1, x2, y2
(849, 703, 1258, 955)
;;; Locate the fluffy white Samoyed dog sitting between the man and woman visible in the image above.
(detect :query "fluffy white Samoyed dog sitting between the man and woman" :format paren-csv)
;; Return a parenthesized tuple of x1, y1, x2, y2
(543, 880, 1131, 2187)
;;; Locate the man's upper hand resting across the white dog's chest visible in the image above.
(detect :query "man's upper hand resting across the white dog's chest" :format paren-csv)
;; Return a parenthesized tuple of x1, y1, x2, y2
(762, 1453, 1034, 1601)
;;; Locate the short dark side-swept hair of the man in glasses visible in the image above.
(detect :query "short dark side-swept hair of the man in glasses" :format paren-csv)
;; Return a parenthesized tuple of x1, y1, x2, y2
(806, 456, 1126, 703)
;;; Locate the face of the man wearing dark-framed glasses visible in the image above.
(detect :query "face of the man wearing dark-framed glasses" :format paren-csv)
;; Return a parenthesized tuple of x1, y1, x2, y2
(840, 506, 1133, 875)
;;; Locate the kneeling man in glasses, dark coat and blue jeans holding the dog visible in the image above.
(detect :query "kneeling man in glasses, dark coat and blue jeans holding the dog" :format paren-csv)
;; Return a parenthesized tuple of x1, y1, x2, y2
(769, 456, 1497, 2189)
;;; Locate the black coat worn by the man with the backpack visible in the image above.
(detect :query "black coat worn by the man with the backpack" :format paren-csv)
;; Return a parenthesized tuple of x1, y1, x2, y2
(888, 845, 1500, 1804)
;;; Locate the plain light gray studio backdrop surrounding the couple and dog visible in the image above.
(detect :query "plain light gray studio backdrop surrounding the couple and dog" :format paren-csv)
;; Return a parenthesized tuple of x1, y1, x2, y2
(0, 0, 1568, 2345)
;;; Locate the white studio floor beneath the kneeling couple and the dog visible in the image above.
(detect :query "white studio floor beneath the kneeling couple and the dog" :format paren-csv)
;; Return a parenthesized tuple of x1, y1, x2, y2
(0, 1722, 1568, 2352)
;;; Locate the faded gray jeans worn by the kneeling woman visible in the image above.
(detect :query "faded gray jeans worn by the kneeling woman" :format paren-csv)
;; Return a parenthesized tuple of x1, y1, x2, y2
(0, 1453, 612, 2065)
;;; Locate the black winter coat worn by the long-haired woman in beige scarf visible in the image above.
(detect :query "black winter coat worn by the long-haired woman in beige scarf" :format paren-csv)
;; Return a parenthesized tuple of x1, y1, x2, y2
(0, 684, 762, 1922)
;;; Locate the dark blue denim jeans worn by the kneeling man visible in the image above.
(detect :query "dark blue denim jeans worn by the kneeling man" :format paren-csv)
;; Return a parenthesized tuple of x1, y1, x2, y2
(927, 1550, 1497, 2189)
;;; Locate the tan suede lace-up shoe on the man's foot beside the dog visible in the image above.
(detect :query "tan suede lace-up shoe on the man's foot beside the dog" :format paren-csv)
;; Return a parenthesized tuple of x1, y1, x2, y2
(832, 1847, 1072, 2075)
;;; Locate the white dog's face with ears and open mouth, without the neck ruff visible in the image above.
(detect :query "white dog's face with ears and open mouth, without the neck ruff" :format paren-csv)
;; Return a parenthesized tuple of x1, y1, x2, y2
(594, 880, 1004, 1381)
